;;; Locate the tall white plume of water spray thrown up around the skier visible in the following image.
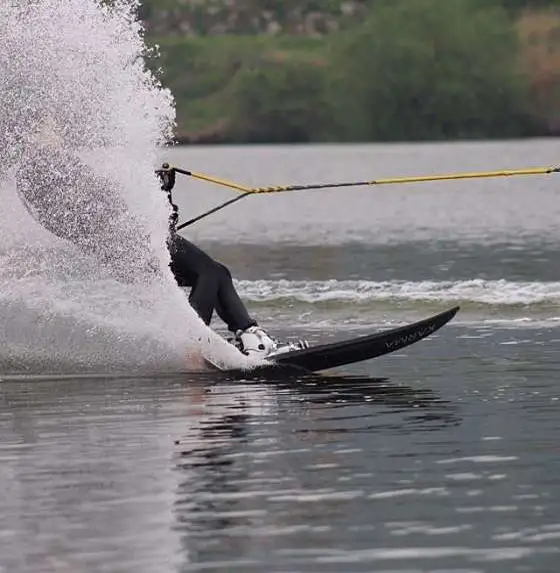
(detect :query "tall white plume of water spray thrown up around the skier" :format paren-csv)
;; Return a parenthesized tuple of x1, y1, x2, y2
(0, 0, 252, 369)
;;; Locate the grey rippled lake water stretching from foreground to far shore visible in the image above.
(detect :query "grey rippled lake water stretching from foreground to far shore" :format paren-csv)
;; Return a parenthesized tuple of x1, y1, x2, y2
(0, 139, 560, 573)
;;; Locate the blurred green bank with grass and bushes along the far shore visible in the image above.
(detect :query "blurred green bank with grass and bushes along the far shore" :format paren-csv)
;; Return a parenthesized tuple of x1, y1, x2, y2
(150, 0, 560, 142)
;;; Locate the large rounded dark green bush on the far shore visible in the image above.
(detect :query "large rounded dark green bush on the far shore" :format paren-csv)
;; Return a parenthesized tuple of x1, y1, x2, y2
(331, 0, 532, 140)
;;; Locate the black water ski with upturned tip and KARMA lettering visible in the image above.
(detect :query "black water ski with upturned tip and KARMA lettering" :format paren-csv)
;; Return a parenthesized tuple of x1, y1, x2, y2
(206, 306, 459, 372)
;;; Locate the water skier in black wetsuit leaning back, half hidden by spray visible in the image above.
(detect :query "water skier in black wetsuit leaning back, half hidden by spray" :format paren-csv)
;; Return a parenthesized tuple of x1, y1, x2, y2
(16, 122, 278, 357)
